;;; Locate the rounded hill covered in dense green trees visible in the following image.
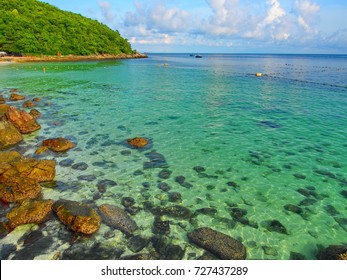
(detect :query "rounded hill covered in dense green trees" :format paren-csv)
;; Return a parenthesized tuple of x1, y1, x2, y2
(0, 0, 135, 55)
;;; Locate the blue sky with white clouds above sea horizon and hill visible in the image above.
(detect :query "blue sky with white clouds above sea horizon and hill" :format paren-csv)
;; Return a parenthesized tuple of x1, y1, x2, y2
(42, 0, 347, 54)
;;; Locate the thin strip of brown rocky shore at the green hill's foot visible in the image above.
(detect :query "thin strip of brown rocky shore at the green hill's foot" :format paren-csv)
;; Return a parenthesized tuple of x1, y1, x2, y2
(0, 53, 148, 65)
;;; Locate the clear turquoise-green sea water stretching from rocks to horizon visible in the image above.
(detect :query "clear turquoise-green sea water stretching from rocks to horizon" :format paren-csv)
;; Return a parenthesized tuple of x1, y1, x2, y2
(0, 54, 347, 259)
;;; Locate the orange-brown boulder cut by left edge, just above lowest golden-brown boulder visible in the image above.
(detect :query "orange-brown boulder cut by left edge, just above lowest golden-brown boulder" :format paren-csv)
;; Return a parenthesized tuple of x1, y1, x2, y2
(0, 177, 41, 202)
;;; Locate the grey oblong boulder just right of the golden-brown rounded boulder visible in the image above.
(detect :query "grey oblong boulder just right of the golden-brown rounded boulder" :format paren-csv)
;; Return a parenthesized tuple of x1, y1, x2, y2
(99, 204, 138, 236)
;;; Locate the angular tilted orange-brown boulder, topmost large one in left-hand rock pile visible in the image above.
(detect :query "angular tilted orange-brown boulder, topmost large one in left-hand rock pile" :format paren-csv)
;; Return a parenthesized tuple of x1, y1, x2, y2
(6, 106, 41, 134)
